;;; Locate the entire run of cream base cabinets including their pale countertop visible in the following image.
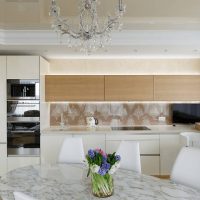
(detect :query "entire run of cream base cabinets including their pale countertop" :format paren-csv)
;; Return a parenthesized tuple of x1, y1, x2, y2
(41, 125, 196, 176)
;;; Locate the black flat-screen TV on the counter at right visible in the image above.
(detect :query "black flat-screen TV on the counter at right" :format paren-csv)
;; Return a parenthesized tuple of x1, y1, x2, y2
(172, 104, 200, 124)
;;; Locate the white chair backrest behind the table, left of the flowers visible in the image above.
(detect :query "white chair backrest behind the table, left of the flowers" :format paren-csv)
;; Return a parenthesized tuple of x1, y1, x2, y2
(58, 137, 85, 164)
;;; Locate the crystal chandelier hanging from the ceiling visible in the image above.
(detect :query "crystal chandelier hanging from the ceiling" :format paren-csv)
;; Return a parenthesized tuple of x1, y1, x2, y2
(49, 0, 125, 53)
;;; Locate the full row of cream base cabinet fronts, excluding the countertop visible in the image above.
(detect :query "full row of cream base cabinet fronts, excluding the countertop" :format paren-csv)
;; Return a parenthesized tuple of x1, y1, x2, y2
(41, 131, 180, 175)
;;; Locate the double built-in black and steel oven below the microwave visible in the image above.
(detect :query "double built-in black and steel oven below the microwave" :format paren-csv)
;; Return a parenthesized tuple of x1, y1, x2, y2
(7, 99, 40, 156)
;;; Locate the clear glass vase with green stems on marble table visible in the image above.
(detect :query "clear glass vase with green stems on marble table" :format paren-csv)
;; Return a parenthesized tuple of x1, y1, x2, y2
(91, 173, 114, 198)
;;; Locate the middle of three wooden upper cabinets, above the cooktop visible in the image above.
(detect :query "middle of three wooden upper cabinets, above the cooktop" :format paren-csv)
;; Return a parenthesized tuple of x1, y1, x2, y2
(105, 75, 153, 101)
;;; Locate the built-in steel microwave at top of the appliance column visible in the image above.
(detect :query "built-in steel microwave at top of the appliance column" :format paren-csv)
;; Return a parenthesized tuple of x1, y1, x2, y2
(7, 79, 40, 100)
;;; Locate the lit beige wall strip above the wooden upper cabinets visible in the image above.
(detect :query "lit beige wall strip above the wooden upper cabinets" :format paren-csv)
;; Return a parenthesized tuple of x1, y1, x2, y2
(49, 59, 200, 75)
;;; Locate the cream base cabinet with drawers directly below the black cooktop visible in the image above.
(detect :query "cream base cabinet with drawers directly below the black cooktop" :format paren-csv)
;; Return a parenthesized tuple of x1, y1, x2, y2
(106, 135, 160, 175)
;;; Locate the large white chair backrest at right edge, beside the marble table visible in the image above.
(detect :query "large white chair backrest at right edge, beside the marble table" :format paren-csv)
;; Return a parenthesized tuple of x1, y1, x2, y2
(171, 147, 200, 189)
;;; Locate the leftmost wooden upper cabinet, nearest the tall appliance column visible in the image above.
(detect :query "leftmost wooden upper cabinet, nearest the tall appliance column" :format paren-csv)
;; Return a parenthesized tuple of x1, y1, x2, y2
(45, 75, 104, 101)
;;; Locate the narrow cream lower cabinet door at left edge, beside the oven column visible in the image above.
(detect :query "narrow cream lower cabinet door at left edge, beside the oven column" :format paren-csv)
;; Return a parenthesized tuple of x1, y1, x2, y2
(0, 144, 7, 176)
